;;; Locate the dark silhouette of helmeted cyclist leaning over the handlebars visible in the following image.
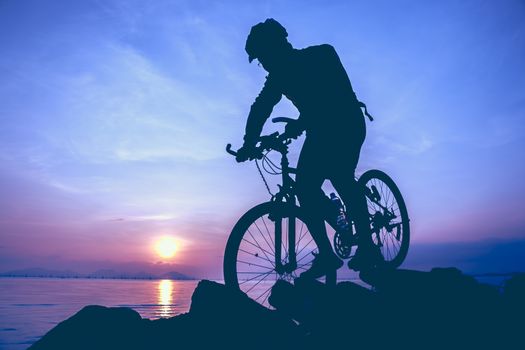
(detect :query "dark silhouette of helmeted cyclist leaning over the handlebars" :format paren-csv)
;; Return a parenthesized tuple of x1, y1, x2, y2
(237, 18, 383, 278)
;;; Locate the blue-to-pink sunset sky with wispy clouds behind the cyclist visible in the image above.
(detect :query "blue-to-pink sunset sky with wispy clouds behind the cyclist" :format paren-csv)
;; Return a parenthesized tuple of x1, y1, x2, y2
(0, 0, 525, 278)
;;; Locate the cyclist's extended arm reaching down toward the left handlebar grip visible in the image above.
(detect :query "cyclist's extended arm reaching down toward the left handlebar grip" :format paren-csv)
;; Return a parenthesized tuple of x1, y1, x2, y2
(244, 75, 282, 146)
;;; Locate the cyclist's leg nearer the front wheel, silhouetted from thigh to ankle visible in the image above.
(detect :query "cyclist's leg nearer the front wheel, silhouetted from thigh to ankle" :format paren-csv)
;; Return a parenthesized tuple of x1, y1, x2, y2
(296, 138, 340, 275)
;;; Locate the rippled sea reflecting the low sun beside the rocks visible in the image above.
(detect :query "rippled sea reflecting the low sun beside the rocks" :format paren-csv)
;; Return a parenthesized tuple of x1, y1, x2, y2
(0, 277, 510, 350)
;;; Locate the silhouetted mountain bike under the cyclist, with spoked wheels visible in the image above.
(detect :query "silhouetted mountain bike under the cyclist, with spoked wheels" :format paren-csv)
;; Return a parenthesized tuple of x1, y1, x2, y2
(223, 118, 410, 307)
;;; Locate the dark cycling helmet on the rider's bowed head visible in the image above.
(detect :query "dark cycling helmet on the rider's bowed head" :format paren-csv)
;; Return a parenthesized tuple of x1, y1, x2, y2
(245, 18, 288, 62)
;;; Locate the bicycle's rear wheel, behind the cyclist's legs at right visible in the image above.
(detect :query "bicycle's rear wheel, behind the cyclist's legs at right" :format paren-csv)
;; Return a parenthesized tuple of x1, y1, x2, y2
(358, 170, 410, 268)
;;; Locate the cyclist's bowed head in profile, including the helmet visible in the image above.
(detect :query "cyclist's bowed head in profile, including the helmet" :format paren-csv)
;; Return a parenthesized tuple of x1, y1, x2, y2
(245, 18, 292, 70)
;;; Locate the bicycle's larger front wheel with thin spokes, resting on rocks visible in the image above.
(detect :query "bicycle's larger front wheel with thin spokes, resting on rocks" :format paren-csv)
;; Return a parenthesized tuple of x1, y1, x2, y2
(223, 202, 335, 308)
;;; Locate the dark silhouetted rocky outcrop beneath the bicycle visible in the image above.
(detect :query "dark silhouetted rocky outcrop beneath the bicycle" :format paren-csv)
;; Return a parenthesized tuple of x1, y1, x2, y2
(31, 268, 525, 349)
